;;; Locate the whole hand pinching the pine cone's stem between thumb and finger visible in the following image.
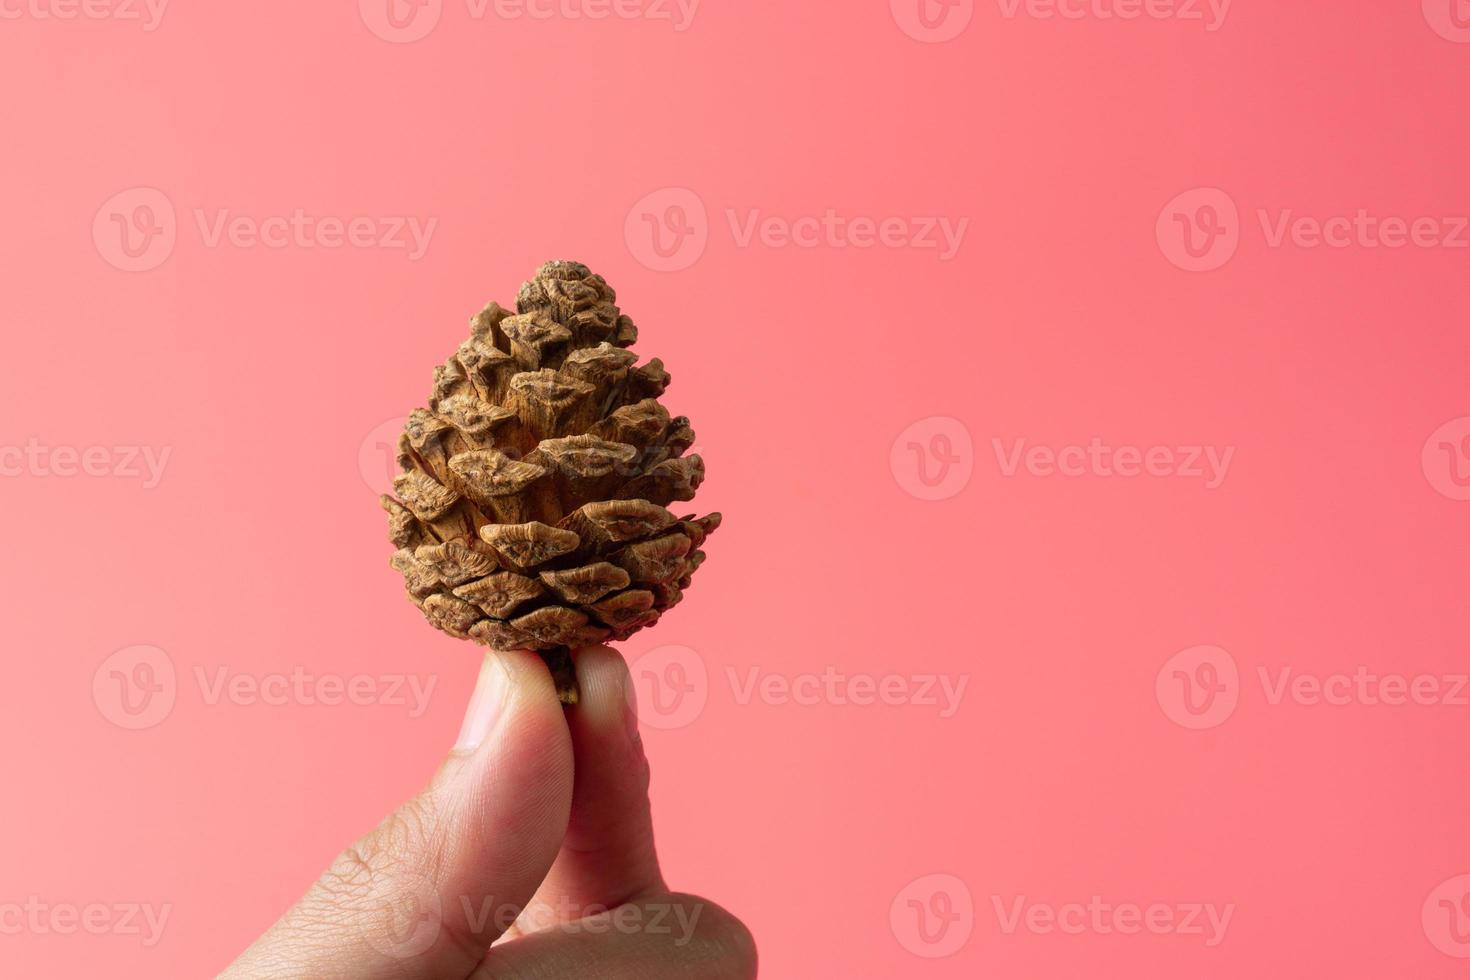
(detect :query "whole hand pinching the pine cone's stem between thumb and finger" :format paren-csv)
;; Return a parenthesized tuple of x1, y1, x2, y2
(222, 646, 756, 980)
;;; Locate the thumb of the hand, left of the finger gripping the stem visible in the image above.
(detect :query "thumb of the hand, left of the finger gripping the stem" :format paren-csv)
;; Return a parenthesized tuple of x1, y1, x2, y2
(222, 652, 572, 980)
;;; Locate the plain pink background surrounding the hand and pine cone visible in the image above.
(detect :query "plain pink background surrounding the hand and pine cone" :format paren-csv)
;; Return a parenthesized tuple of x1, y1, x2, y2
(0, 0, 1470, 980)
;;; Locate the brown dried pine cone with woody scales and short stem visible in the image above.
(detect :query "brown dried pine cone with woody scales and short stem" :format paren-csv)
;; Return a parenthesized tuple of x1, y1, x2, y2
(382, 262, 720, 704)
